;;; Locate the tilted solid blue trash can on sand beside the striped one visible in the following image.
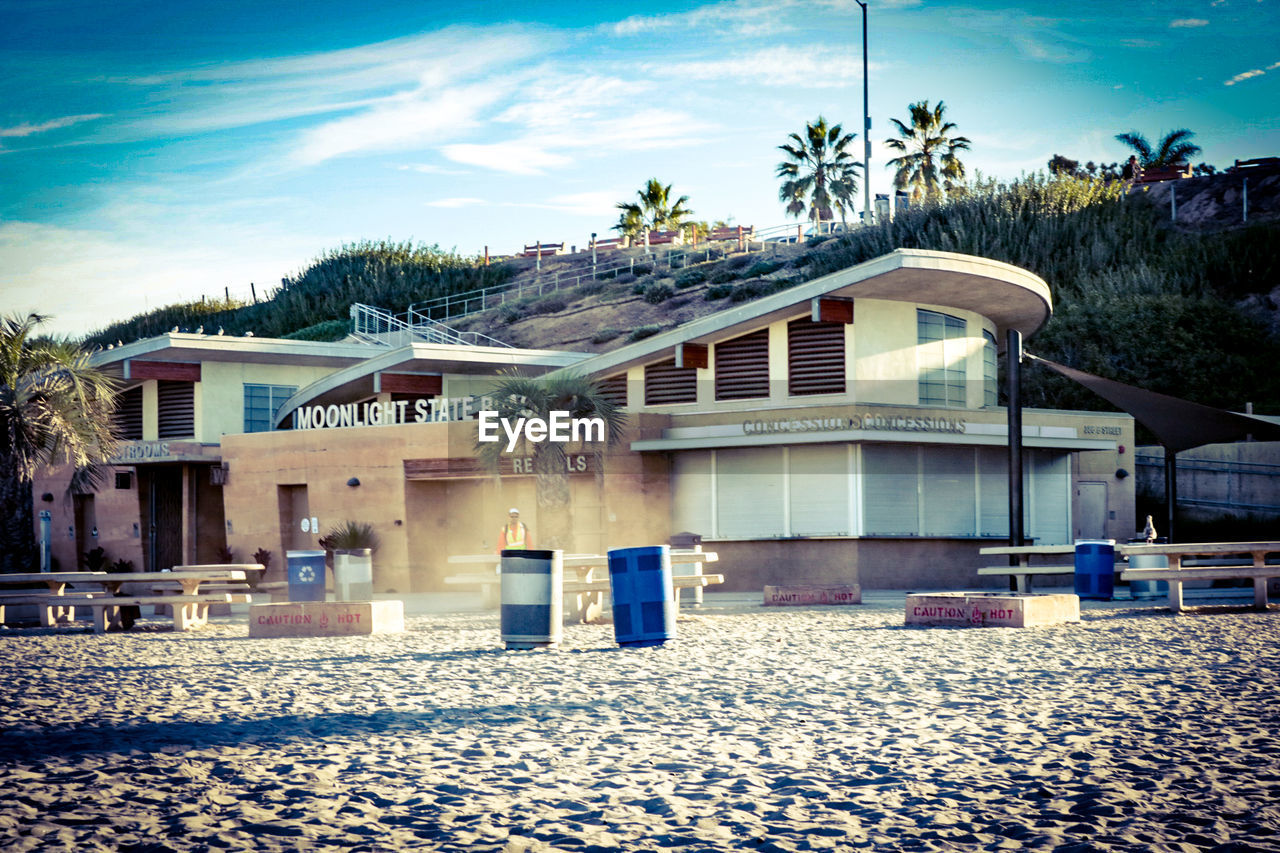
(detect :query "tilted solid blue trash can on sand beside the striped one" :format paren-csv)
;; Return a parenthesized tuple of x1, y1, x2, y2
(609, 546, 676, 646)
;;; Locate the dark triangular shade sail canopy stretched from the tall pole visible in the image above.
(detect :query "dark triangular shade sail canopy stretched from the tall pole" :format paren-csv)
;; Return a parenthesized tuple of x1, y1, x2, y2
(1027, 353, 1280, 453)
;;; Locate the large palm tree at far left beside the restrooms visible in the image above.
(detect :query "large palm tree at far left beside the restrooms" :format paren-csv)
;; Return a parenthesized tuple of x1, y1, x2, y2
(0, 314, 115, 571)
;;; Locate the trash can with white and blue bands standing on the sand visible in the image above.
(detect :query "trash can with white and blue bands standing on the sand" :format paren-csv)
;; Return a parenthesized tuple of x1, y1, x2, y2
(500, 548, 564, 649)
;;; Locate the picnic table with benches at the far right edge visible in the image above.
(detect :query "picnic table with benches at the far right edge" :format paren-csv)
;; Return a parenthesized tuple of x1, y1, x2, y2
(1120, 542, 1280, 613)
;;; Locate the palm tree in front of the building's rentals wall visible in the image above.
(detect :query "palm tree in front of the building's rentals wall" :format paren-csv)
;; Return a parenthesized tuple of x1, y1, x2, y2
(476, 374, 627, 548)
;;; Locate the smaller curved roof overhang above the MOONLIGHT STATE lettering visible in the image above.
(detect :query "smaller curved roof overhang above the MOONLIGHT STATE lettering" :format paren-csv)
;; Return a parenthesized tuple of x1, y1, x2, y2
(276, 335, 589, 425)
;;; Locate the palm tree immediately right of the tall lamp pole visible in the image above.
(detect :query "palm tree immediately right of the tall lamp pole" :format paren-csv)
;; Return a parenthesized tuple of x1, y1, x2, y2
(884, 101, 969, 201)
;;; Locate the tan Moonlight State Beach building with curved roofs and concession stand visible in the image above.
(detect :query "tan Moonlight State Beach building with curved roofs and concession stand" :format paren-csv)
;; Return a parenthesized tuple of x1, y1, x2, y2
(36, 250, 1135, 592)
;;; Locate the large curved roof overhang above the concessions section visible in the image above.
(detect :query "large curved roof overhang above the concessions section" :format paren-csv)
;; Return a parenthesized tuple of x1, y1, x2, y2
(550, 248, 1053, 374)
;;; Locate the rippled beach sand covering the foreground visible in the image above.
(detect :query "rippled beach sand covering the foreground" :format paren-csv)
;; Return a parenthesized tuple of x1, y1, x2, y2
(0, 596, 1280, 853)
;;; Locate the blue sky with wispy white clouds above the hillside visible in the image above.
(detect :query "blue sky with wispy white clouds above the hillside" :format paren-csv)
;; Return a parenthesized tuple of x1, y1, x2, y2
(0, 0, 1280, 337)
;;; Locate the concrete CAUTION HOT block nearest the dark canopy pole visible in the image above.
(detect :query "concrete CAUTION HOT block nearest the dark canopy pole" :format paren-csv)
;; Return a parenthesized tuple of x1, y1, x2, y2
(906, 592, 1080, 628)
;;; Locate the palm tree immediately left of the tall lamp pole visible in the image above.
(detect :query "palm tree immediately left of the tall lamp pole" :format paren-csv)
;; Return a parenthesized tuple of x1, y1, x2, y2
(777, 115, 861, 227)
